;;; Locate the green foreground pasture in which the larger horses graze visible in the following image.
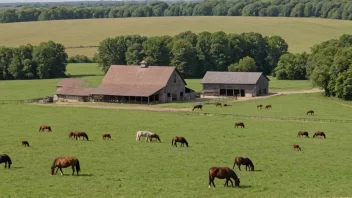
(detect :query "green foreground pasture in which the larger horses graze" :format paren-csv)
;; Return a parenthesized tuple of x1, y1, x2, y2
(0, 105, 352, 197)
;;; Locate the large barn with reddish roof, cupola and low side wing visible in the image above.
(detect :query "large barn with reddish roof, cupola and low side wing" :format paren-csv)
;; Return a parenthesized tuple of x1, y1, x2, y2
(56, 61, 194, 104)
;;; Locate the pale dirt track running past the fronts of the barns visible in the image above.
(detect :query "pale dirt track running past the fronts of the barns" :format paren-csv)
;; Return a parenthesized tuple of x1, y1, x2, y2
(37, 89, 321, 112)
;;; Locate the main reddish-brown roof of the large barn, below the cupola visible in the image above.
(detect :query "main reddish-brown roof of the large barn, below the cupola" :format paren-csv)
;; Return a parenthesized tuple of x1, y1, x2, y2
(92, 65, 186, 96)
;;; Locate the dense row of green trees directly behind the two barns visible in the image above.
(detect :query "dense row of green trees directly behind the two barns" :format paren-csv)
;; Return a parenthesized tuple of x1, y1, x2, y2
(95, 31, 288, 78)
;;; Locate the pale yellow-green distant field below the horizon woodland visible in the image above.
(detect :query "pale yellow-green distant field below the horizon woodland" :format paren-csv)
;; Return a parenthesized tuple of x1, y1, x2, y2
(0, 16, 352, 56)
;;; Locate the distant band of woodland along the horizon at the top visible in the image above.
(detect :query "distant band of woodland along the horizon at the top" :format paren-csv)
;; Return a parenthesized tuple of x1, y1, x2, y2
(0, 0, 352, 23)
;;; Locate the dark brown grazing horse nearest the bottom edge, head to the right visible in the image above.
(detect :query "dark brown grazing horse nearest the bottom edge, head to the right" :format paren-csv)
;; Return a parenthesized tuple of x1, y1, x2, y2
(208, 166, 240, 188)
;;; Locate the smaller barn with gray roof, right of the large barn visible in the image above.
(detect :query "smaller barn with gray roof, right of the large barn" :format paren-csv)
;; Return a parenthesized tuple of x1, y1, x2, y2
(201, 71, 269, 97)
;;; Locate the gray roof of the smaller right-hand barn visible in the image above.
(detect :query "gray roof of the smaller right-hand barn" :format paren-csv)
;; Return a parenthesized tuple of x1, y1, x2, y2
(201, 71, 269, 85)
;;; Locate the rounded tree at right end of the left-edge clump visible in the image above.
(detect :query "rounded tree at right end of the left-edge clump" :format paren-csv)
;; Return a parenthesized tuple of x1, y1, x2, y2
(33, 41, 67, 79)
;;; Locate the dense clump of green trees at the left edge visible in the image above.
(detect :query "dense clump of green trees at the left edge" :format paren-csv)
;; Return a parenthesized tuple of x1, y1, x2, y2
(0, 41, 67, 80)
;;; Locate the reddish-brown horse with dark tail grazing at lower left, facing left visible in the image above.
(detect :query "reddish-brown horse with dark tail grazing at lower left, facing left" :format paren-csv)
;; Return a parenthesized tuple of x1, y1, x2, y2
(50, 157, 81, 176)
